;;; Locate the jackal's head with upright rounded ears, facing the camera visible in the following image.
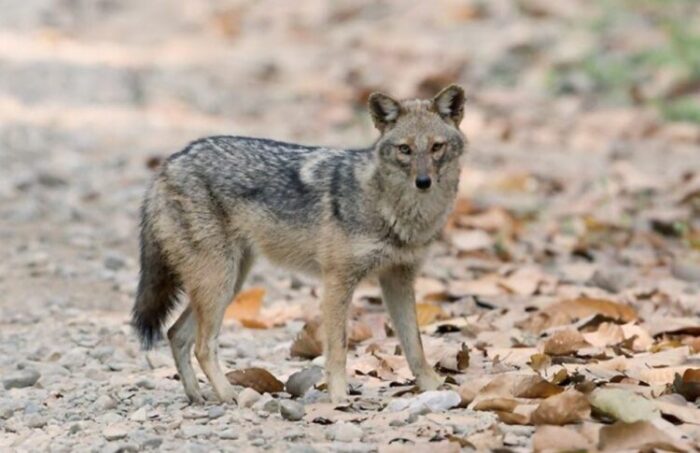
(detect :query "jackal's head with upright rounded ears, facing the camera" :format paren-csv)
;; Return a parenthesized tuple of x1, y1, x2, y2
(369, 85, 466, 192)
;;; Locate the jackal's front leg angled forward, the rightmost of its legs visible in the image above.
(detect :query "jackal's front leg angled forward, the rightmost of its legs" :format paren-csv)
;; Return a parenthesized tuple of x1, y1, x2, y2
(379, 266, 444, 390)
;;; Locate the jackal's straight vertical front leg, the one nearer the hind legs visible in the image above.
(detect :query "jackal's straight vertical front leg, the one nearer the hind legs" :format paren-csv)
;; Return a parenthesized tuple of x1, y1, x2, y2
(321, 273, 356, 403)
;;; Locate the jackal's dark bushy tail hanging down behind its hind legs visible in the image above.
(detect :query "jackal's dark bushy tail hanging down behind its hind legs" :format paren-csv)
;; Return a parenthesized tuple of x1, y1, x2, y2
(131, 214, 181, 349)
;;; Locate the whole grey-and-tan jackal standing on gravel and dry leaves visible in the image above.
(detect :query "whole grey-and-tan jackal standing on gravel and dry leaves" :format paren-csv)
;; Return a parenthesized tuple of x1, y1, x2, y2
(133, 85, 465, 401)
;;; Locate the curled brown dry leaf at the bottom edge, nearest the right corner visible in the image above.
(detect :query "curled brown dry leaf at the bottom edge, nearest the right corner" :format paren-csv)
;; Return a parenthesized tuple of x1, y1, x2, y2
(598, 421, 687, 451)
